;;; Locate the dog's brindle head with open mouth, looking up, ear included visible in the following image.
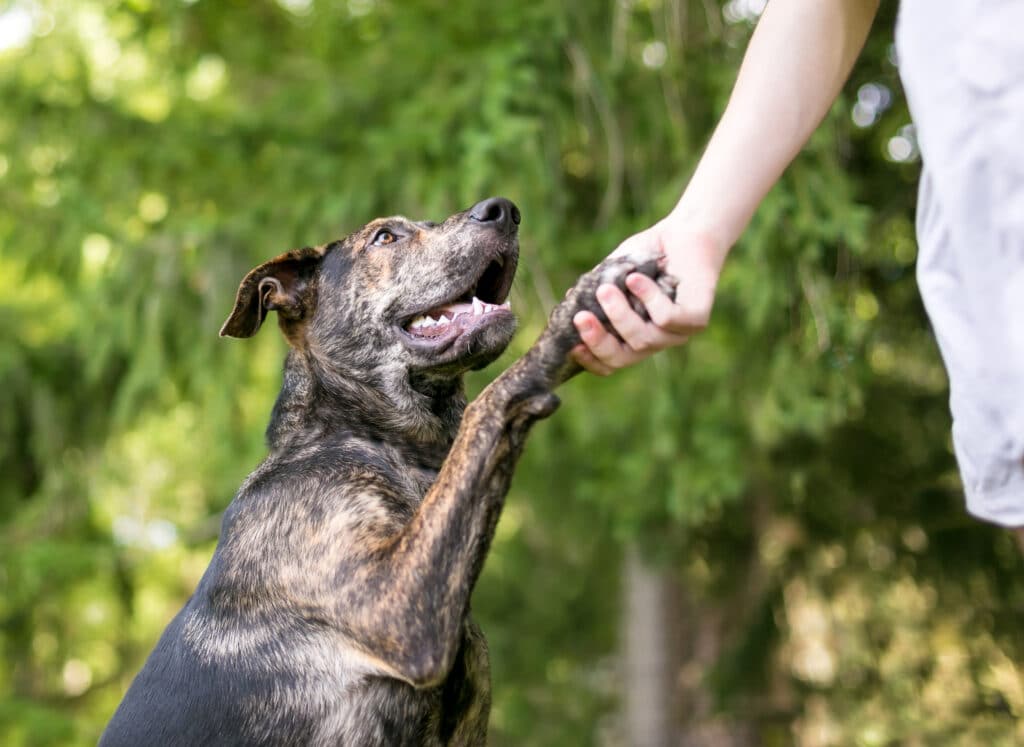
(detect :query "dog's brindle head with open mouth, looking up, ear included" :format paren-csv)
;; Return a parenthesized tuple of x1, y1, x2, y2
(220, 198, 519, 377)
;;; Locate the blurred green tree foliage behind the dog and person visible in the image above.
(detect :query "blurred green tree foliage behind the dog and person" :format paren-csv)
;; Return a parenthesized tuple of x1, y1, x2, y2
(0, 0, 1024, 747)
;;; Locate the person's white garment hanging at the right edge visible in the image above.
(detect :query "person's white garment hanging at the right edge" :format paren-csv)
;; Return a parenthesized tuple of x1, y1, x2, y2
(896, 0, 1024, 526)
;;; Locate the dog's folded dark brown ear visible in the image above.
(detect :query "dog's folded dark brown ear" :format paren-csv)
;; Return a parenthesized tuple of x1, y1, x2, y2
(220, 247, 325, 337)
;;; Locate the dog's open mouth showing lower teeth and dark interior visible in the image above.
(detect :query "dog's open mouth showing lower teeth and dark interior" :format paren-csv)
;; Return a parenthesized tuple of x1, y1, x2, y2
(402, 257, 515, 343)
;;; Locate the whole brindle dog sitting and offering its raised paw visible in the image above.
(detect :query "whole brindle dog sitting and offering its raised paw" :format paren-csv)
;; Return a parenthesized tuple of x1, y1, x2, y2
(100, 199, 673, 747)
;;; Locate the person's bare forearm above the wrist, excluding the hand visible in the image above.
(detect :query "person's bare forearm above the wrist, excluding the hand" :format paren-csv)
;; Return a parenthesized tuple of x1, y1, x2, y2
(669, 0, 880, 253)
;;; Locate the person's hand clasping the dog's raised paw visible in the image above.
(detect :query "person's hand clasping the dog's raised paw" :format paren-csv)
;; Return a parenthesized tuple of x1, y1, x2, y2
(572, 219, 726, 376)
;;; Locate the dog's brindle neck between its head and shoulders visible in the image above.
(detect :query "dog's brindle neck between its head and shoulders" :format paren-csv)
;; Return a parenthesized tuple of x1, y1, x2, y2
(266, 349, 466, 469)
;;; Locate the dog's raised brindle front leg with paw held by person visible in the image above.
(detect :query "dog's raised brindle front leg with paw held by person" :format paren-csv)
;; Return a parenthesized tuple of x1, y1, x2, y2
(342, 253, 675, 687)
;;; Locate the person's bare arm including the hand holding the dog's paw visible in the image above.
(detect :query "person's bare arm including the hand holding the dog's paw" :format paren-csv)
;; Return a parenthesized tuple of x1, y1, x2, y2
(573, 0, 880, 374)
